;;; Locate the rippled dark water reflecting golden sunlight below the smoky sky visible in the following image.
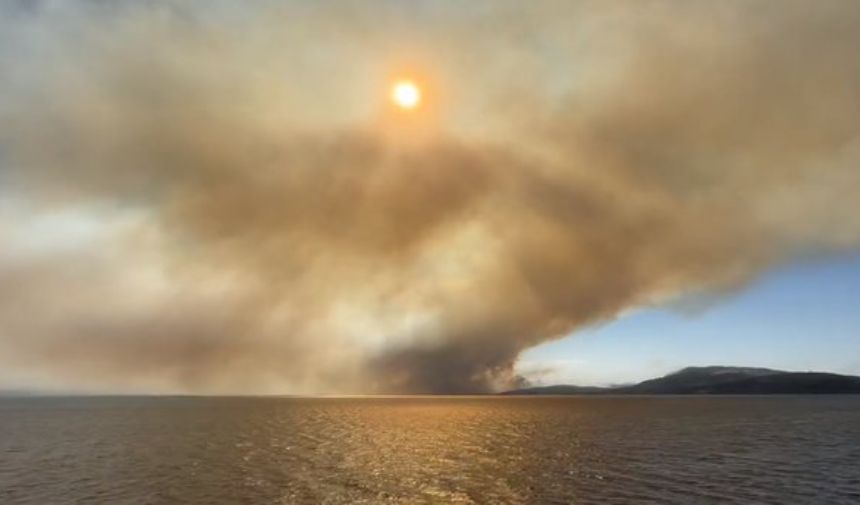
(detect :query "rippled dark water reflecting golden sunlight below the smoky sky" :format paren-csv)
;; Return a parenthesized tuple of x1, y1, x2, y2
(0, 396, 860, 505)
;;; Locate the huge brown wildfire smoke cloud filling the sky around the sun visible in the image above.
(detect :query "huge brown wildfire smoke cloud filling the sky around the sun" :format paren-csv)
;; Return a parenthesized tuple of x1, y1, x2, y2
(0, 0, 860, 392)
